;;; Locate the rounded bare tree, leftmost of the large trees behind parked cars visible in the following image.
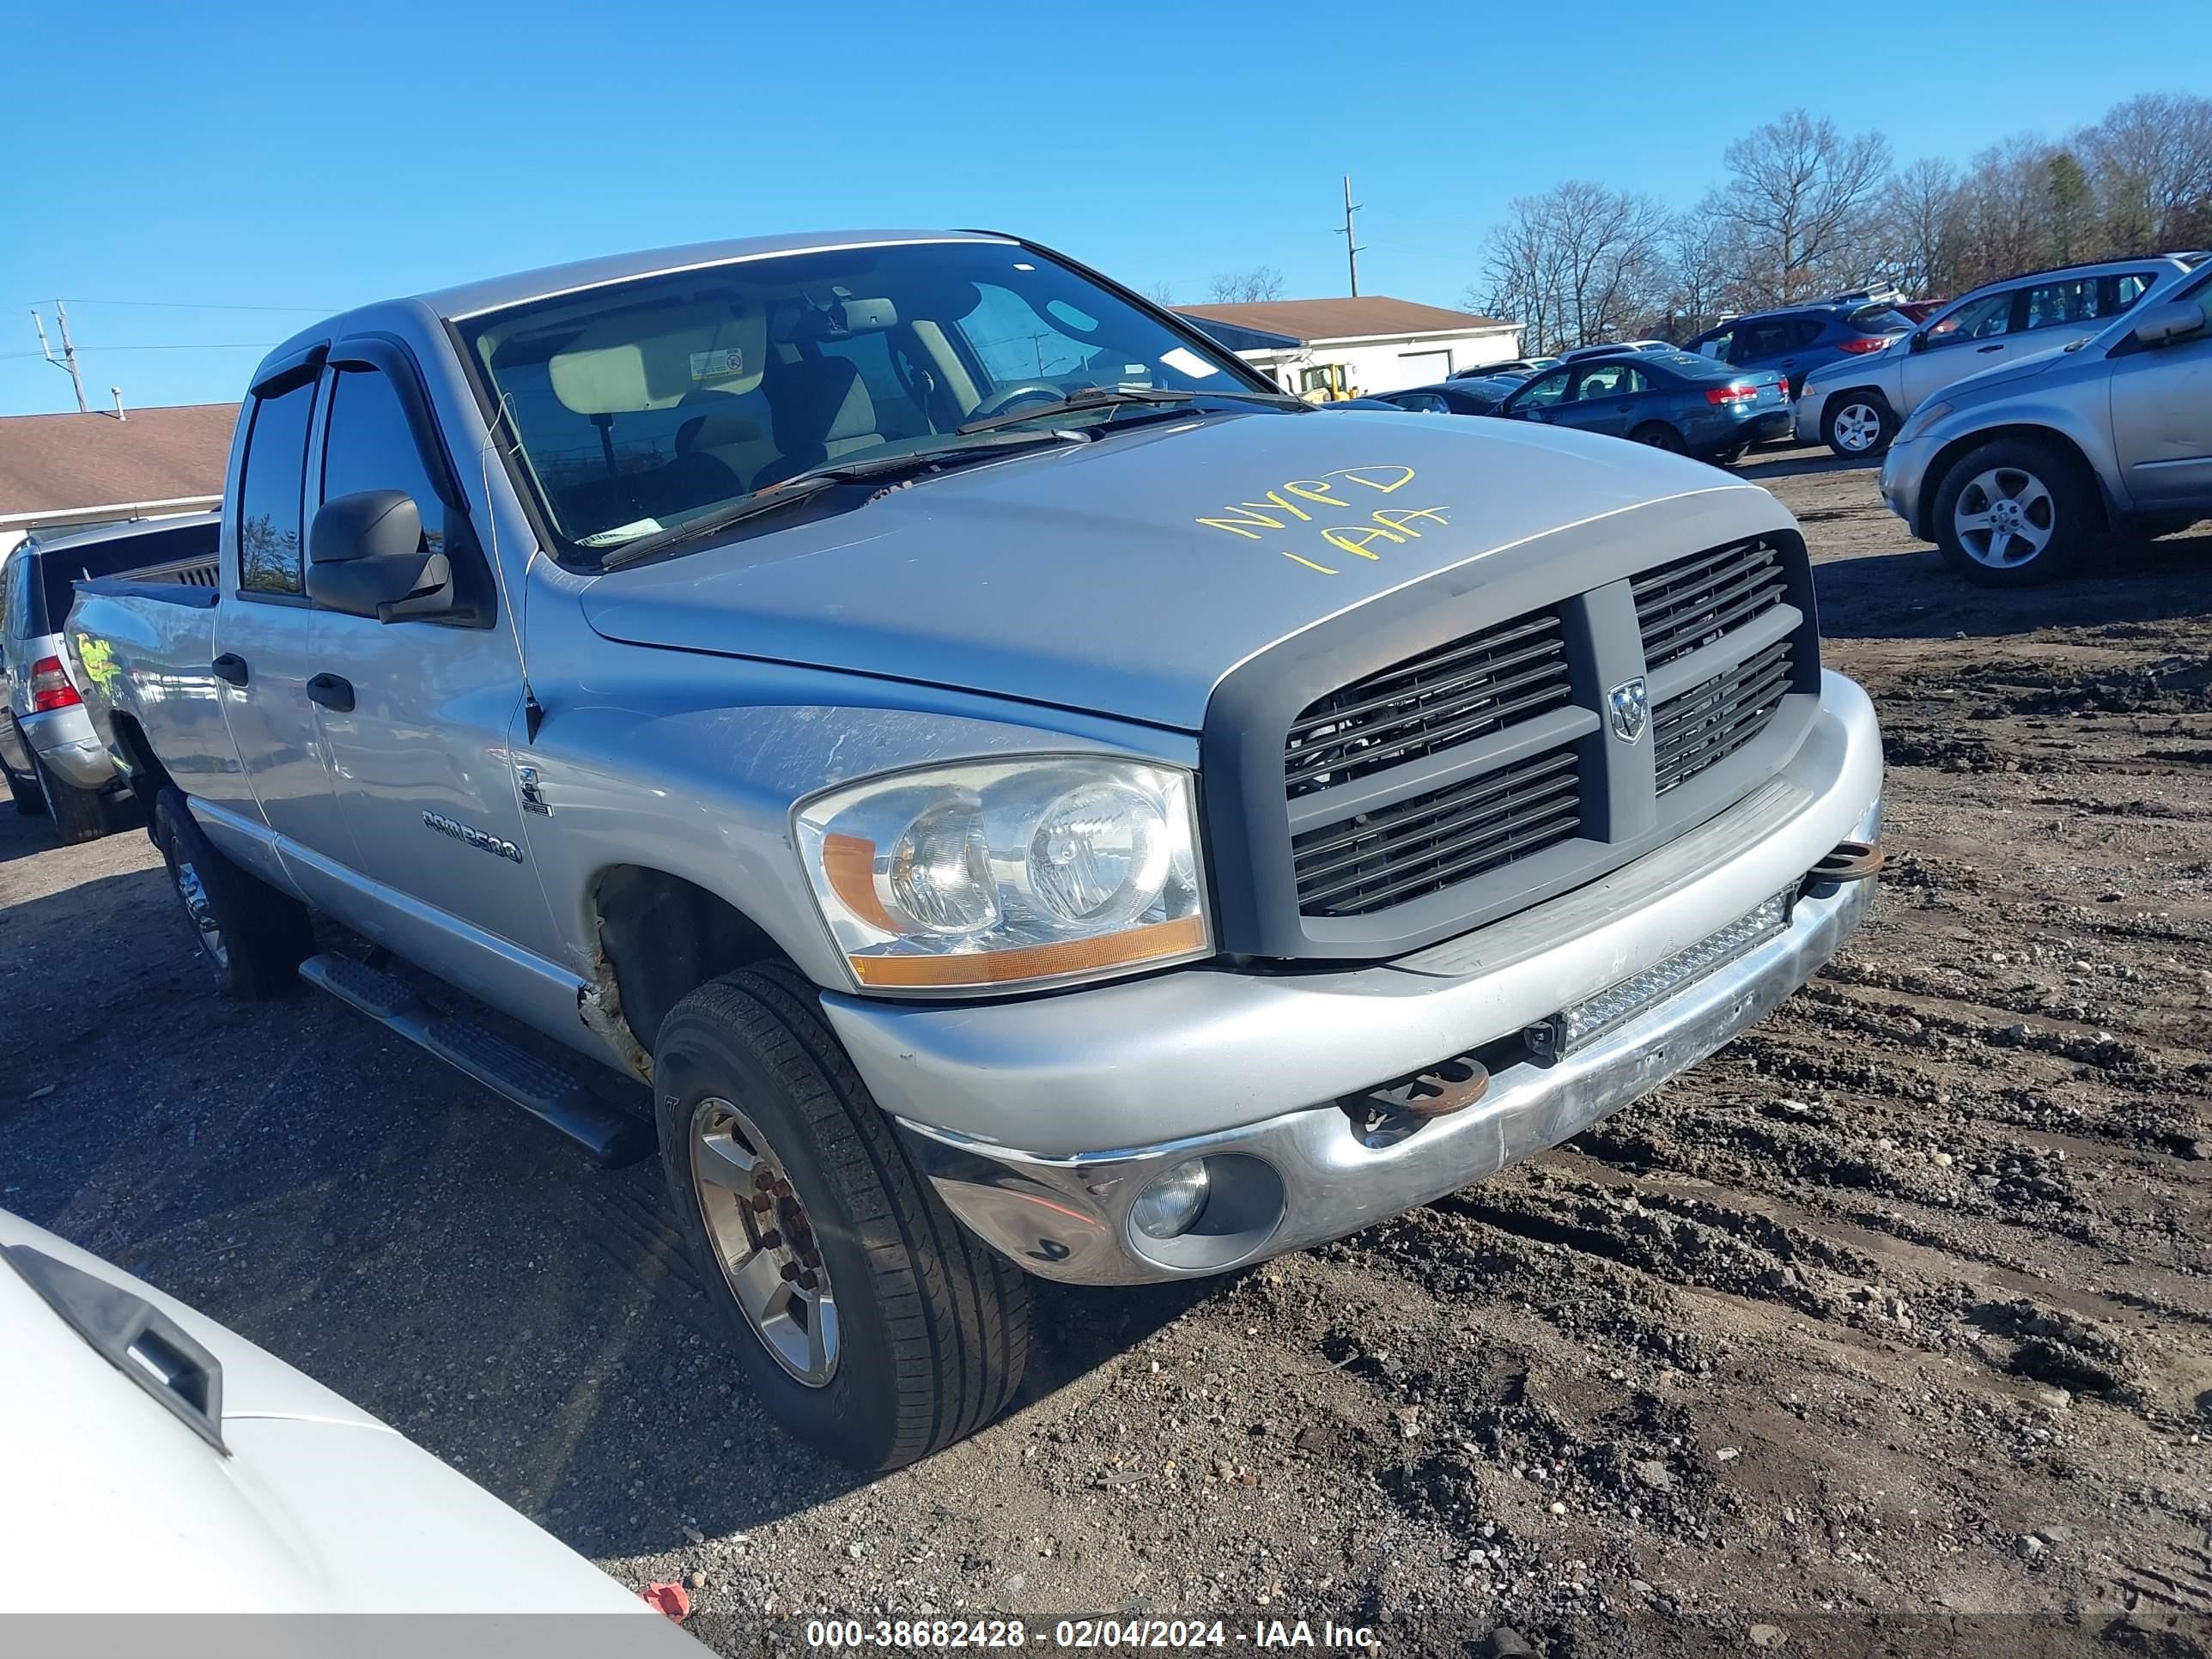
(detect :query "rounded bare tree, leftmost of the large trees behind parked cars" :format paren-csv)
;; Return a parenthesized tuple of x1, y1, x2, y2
(1484, 179, 1668, 352)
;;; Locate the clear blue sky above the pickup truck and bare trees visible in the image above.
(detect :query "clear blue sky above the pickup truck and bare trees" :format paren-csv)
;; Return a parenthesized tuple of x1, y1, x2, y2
(0, 0, 2212, 414)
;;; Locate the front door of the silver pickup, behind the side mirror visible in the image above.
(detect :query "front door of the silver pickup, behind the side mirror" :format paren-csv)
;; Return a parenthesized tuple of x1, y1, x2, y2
(310, 341, 557, 956)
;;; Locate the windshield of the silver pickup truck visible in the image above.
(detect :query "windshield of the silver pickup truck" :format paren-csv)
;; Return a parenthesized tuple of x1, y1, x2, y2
(460, 241, 1265, 557)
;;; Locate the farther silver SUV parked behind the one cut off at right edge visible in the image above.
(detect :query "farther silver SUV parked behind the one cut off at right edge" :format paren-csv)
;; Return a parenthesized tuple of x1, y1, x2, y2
(1796, 254, 2203, 458)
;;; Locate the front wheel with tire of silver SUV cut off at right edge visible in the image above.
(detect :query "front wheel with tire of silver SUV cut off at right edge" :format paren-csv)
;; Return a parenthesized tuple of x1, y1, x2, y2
(1933, 438, 2097, 588)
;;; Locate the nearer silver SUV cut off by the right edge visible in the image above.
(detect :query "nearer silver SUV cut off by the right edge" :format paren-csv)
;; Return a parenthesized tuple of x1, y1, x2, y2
(1882, 270, 2212, 586)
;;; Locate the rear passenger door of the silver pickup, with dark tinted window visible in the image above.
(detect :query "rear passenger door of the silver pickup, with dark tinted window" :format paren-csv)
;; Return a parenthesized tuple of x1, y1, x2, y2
(208, 362, 345, 852)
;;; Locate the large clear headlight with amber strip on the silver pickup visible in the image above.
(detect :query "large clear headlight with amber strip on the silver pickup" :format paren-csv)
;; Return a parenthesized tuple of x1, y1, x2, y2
(799, 757, 1212, 991)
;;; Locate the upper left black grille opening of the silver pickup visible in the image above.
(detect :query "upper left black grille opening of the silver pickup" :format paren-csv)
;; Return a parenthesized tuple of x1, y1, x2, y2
(1283, 611, 1571, 801)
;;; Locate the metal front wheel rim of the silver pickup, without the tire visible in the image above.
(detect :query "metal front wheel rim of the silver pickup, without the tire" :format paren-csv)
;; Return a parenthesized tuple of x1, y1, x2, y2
(690, 1097, 841, 1389)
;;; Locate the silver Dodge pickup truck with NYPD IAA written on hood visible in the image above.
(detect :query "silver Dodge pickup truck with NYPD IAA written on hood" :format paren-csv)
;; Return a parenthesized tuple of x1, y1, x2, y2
(69, 232, 1882, 1467)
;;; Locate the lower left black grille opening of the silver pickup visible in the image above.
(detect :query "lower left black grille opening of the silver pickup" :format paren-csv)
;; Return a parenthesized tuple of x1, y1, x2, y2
(1290, 748, 1582, 915)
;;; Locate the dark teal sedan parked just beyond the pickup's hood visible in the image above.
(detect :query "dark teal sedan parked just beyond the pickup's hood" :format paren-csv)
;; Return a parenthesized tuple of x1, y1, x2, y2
(1498, 345, 1790, 465)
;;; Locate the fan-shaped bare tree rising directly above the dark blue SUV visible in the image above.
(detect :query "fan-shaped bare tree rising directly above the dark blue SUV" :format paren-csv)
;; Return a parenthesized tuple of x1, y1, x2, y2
(1719, 108, 1889, 303)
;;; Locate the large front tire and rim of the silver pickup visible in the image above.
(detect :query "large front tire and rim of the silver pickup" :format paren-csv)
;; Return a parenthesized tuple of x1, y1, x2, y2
(654, 967, 1029, 1471)
